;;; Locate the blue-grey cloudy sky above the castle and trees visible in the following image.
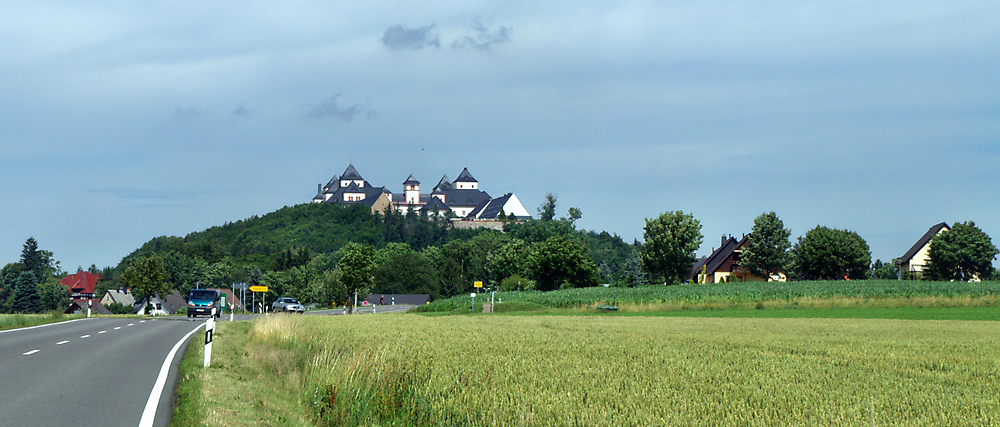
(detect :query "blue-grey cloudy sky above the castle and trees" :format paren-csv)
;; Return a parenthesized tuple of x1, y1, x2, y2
(0, 0, 1000, 271)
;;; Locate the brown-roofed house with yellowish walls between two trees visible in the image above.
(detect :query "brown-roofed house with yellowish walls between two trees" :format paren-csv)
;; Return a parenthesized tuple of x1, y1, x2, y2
(687, 234, 787, 283)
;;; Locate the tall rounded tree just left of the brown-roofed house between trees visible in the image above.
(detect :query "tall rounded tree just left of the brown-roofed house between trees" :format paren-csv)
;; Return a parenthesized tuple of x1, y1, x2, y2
(640, 211, 702, 284)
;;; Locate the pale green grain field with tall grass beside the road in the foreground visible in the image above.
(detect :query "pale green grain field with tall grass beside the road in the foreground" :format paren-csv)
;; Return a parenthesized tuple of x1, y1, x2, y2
(189, 314, 1000, 426)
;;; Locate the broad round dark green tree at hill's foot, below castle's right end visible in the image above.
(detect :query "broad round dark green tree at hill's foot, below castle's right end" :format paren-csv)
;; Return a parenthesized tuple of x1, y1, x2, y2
(527, 235, 599, 291)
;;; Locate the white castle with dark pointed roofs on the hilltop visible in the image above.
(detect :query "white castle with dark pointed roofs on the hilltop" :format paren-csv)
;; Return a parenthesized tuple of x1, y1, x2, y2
(313, 164, 531, 221)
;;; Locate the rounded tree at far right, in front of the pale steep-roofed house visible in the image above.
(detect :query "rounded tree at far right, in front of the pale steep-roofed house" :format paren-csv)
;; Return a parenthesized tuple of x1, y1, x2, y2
(924, 221, 997, 282)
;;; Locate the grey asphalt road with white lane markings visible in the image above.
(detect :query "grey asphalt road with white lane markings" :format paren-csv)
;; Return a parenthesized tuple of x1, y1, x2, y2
(0, 317, 205, 427)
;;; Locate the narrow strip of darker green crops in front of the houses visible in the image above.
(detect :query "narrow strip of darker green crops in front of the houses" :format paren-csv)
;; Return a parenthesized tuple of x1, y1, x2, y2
(418, 280, 1000, 312)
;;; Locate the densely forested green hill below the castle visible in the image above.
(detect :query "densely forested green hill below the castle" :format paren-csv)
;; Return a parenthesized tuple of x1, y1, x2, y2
(109, 203, 638, 302)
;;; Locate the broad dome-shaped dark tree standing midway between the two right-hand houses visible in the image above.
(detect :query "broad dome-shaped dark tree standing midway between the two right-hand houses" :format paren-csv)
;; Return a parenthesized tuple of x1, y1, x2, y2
(794, 225, 871, 280)
